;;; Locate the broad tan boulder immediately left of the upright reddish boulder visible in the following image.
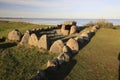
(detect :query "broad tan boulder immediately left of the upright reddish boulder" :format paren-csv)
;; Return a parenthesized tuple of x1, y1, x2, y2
(50, 40, 64, 53)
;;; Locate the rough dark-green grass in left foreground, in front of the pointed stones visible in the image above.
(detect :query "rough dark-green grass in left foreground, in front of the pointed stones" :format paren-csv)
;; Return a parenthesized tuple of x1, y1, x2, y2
(0, 46, 55, 80)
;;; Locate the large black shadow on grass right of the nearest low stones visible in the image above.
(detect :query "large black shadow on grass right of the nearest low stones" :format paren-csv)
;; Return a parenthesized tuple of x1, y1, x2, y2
(46, 59, 77, 80)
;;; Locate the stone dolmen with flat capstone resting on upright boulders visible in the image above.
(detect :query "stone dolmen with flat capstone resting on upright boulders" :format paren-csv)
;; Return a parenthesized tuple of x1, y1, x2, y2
(61, 21, 77, 35)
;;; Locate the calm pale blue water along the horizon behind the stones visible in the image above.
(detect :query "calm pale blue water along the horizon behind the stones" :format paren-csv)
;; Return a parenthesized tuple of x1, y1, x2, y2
(0, 18, 120, 26)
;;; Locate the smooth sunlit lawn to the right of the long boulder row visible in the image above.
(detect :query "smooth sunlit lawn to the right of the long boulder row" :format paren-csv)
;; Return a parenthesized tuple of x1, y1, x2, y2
(65, 28, 120, 80)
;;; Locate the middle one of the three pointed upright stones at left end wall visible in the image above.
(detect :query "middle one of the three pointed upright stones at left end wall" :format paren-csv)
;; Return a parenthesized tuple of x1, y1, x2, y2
(28, 33, 38, 46)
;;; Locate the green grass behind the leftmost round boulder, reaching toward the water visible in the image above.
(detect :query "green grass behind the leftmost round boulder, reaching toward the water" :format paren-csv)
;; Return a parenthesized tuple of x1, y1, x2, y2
(0, 21, 49, 37)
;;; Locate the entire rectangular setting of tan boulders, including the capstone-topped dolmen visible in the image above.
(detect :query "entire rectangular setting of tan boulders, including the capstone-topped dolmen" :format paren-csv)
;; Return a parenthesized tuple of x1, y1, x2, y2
(7, 21, 99, 80)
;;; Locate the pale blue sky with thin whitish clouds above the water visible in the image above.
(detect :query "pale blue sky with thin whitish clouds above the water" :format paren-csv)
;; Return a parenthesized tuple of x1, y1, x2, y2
(0, 0, 120, 19)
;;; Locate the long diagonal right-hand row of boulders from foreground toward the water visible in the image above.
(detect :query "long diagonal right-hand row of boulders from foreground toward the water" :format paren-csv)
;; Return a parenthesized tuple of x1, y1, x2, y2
(31, 25, 99, 80)
